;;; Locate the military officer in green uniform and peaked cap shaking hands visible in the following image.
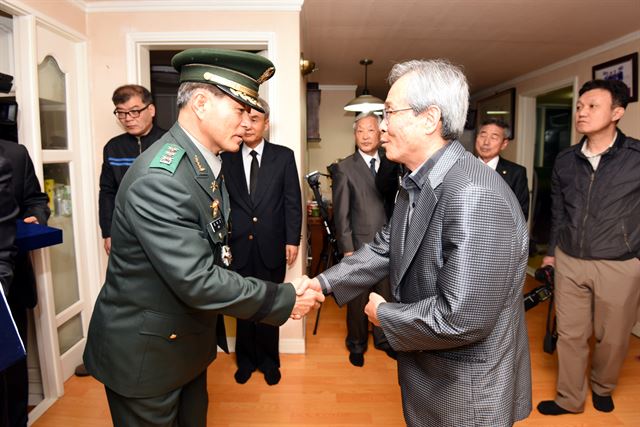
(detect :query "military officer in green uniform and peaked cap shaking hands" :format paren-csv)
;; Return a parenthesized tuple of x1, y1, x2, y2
(84, 49, 324, 427)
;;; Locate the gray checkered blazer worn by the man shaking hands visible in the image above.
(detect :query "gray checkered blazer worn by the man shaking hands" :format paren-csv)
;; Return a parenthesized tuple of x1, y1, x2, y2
(320, 142, 531, 427)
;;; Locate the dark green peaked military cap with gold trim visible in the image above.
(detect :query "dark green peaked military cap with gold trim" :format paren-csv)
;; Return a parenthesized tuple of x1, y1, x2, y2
(171, 48, 276, 113)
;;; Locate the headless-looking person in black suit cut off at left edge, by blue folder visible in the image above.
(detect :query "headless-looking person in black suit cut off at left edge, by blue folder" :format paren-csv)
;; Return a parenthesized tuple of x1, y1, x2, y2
(0, 140, 50, 427)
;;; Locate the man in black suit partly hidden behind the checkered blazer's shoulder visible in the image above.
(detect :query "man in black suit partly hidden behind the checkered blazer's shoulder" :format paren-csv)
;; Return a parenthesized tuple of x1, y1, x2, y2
(476, 118, 529, 219)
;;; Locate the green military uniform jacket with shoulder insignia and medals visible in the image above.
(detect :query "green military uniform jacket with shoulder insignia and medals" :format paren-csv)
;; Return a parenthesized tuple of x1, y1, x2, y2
(84, 123, 295, 397)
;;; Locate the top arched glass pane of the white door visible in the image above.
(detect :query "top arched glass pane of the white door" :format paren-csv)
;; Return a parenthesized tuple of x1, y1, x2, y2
(38, 56, 68, 150)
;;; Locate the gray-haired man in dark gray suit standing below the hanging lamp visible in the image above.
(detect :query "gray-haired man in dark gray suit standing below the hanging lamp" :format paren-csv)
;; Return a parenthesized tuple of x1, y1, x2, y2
(331, 113, 398, 366)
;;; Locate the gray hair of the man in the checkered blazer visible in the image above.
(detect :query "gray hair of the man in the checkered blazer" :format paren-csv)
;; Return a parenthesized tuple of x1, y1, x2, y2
(388, 59, 469, 140)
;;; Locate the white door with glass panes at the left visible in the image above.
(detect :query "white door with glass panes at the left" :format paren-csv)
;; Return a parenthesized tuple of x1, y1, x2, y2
(36, 20, 97, 380)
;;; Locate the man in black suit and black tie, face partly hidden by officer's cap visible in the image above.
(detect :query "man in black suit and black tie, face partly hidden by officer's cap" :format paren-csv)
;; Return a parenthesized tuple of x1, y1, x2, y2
(222, 98, 302, 385)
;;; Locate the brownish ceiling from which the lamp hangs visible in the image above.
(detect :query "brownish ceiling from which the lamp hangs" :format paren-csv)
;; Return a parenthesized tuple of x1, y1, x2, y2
(301, 0, 640, 98)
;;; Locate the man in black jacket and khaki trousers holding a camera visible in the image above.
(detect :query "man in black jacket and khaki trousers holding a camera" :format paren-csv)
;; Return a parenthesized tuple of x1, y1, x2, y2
(538, 80, 640, 415)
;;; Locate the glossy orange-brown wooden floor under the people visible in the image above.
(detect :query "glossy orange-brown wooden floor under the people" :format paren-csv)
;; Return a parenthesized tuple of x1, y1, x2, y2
(34, 280, 640, 427)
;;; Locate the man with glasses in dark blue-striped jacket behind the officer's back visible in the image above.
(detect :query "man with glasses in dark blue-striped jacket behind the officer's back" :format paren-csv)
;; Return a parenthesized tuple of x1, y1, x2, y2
(98, 85, 165, 255)
